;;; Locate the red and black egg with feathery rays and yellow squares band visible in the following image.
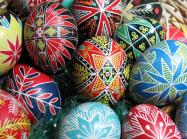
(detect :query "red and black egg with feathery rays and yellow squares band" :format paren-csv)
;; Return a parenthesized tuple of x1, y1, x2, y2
(24, 2, 78, 73)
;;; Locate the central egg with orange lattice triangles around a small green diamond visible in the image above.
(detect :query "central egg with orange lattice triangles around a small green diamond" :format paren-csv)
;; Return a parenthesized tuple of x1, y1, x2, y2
(70, 36, 130, 104)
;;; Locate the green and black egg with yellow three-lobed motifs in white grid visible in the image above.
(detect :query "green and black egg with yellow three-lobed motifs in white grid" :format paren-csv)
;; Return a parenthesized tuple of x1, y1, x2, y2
(114, 18, 164, 63)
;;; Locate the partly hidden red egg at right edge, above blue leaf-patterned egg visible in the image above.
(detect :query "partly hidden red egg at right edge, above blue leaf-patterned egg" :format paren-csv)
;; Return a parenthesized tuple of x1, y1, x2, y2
(164, 25, 187, 43)
